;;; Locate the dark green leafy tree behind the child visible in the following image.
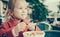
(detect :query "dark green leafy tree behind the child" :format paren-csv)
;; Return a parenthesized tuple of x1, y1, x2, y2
(26, 0, 48, 21)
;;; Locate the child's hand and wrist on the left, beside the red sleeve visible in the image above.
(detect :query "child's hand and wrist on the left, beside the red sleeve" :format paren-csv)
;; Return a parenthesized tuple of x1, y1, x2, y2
(12, 22, 26, 35)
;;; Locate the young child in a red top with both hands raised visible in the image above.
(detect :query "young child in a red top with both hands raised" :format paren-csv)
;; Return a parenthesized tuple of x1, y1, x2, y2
(0, 0, 40, 37)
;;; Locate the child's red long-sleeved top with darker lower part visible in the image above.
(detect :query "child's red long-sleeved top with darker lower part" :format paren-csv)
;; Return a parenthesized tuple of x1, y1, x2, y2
(0, 18, 40, 37)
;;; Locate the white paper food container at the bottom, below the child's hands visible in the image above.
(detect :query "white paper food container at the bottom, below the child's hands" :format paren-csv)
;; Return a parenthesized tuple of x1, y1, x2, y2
(23, 31, 45, 37)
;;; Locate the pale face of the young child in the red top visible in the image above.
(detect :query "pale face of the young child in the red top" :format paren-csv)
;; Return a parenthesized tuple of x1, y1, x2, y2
(13, 1, 29, 19)
